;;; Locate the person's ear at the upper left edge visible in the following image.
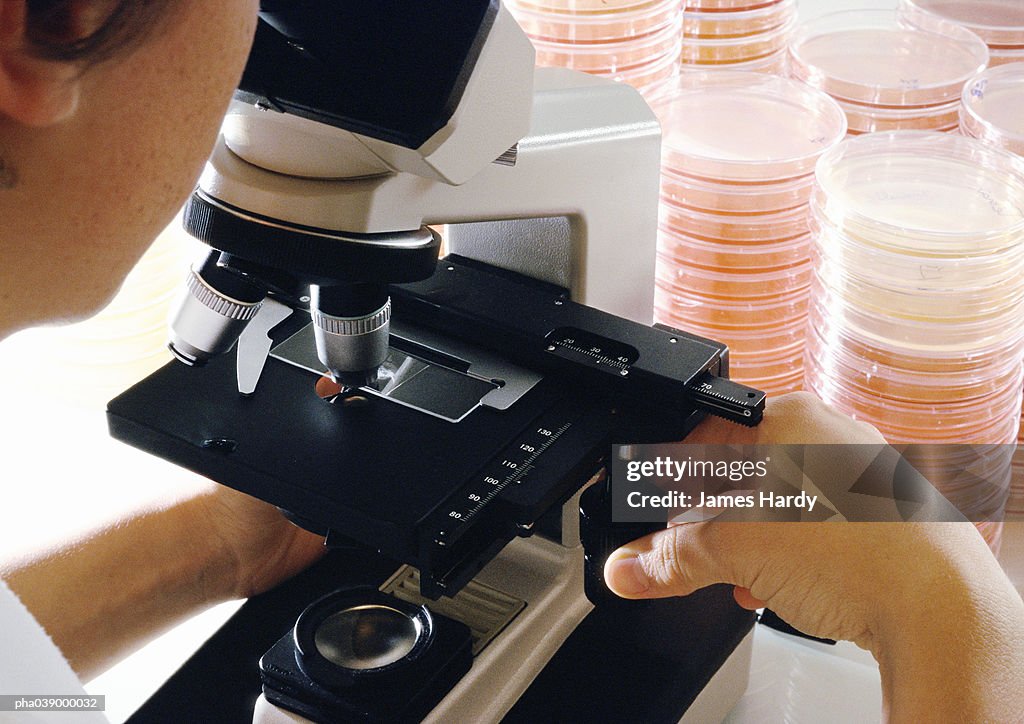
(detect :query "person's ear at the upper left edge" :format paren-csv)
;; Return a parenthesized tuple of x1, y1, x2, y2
(0, 0, 80, 126)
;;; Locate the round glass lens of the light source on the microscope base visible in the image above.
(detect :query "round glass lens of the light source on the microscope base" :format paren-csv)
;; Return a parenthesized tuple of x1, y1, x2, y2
(313, 605, 423, 671)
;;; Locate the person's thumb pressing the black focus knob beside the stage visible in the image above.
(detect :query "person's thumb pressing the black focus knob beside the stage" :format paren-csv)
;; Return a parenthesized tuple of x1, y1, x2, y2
(604, 523, 738, 598)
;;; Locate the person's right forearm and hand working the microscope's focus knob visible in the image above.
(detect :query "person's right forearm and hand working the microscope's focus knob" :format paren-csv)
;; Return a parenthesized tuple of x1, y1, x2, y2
(605, 394, 1024, 722)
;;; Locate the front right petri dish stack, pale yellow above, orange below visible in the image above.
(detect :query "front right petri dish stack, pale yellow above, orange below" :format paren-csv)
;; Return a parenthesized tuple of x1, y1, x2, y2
(806, 131, 1024, 547)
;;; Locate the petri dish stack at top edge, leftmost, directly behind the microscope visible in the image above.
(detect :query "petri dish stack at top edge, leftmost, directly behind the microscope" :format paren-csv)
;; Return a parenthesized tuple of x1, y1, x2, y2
(506, 0, 682, 91)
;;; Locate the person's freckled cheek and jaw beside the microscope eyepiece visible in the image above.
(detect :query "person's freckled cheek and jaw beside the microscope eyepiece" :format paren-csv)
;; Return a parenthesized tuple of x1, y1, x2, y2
(0, 0, 259, 338)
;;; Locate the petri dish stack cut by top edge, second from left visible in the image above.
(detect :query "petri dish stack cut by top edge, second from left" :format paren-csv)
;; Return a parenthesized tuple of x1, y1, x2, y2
(682, 0, 797, 75)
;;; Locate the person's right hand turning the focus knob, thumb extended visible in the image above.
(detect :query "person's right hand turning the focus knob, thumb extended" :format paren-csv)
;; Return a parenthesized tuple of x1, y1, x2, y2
(605, 393, 993, 650)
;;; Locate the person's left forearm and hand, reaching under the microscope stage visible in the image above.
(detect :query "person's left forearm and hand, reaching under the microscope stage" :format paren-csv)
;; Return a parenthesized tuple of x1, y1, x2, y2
(2, 486, 324, 680)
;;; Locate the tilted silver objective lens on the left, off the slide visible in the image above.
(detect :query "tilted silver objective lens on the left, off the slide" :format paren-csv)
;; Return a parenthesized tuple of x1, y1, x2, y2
(168, 269, 263, 365)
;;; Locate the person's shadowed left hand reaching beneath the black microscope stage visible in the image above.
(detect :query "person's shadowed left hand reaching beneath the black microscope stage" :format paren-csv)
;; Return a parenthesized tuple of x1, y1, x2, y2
(197, 485, 326, 598)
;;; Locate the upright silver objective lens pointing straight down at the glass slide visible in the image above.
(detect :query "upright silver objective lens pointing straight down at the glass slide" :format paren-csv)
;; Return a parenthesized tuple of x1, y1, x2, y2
(311, 298, 391, 387)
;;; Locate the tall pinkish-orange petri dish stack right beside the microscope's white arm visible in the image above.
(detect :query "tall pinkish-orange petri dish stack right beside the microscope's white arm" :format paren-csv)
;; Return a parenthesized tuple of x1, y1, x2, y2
(651, 71, 846, 393)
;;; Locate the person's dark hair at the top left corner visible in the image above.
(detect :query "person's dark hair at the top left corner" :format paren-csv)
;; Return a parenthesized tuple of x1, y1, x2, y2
(24, 0, 171, 65)
